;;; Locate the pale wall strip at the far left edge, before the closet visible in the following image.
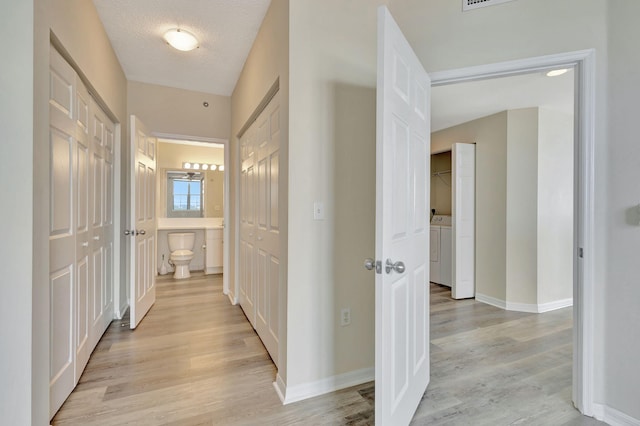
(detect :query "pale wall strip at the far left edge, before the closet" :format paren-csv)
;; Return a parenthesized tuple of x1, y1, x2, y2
(0, 1, 34, 425)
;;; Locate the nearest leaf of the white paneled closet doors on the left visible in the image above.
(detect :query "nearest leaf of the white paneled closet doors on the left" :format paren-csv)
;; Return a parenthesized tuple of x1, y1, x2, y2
(49, 47, 79, 416)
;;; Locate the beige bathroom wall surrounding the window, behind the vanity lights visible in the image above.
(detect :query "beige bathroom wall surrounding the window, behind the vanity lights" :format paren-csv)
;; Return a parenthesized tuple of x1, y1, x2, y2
(156, 142, 224, 217)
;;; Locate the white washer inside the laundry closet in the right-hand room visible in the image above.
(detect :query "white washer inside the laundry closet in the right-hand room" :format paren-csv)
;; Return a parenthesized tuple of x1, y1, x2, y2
(429, 215, 452, 287)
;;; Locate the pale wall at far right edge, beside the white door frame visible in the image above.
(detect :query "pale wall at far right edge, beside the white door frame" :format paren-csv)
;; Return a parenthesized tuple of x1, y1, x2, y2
(595, 0, 640, 423)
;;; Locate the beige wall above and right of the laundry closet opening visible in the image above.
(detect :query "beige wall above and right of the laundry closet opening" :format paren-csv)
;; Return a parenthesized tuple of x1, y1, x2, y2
(431, 111, 507, 300)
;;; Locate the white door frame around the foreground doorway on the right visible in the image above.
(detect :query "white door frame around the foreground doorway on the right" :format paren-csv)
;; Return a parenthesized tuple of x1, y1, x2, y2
(430, 49, 596, 417)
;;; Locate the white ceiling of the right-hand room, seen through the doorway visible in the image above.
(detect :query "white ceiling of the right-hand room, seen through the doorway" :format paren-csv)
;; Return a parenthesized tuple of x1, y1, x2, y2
(431, 70, 574, 132)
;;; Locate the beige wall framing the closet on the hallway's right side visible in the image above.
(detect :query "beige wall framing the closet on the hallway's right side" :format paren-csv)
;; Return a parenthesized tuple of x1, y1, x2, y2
(230, 0, 289, 380)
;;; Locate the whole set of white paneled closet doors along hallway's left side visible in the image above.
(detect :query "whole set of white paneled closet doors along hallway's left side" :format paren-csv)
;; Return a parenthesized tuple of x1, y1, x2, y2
(49, 46, 115, 417)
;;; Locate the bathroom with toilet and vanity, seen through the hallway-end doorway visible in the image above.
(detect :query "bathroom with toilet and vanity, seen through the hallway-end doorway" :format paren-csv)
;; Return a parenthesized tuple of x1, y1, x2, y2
(156, 139, 225, 279)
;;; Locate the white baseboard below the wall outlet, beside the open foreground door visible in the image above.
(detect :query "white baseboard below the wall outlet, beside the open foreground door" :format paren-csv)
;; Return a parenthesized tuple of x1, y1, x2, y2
(273, 368, 375, 405)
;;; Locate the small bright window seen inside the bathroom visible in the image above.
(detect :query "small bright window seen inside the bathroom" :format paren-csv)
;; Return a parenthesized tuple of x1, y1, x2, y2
(167, 172, 204, 217)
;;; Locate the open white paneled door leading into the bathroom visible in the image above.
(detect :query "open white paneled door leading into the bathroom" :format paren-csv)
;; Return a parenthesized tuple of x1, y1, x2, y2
(126, 115, 157, 328)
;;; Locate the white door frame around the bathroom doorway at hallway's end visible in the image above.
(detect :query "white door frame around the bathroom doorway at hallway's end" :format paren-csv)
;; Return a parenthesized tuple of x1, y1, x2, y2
(150, 129, 231, 297)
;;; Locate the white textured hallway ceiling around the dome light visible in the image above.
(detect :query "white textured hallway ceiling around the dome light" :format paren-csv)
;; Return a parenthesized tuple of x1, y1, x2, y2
(93, 0, 270, 96)
